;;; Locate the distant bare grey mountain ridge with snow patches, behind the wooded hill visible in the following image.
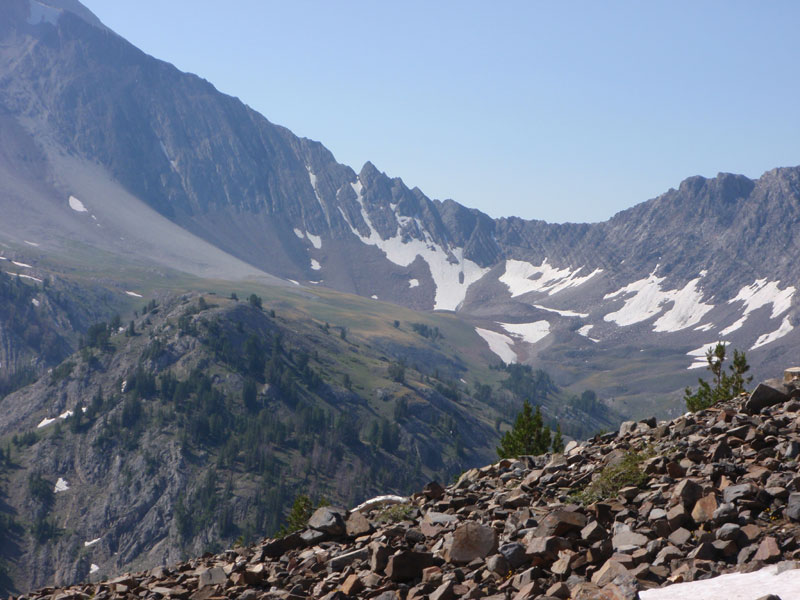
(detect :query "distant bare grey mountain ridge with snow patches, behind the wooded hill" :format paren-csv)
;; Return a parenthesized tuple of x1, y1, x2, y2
(0, 0, 800, 412)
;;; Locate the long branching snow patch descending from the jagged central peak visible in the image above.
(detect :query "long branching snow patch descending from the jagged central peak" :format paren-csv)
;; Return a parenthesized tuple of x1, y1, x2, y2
(342, 180, 489, 310)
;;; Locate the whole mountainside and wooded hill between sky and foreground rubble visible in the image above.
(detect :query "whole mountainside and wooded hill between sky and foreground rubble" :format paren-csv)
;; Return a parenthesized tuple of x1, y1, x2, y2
(0, 0, 800, 591)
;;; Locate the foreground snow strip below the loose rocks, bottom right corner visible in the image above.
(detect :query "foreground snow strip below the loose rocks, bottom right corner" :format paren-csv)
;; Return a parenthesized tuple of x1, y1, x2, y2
(639, 565, 800, 600)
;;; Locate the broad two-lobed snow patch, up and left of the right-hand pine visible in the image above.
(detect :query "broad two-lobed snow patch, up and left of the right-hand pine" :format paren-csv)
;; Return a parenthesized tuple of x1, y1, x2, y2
(603, 265, 714, 332)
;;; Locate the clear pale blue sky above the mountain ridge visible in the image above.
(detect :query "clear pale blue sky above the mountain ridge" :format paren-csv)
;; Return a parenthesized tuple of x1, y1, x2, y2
(83, 0, 800, 222)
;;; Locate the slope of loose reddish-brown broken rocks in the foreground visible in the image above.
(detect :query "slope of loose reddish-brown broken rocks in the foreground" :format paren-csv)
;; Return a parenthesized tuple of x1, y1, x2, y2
(14, 372, 800, 600)
